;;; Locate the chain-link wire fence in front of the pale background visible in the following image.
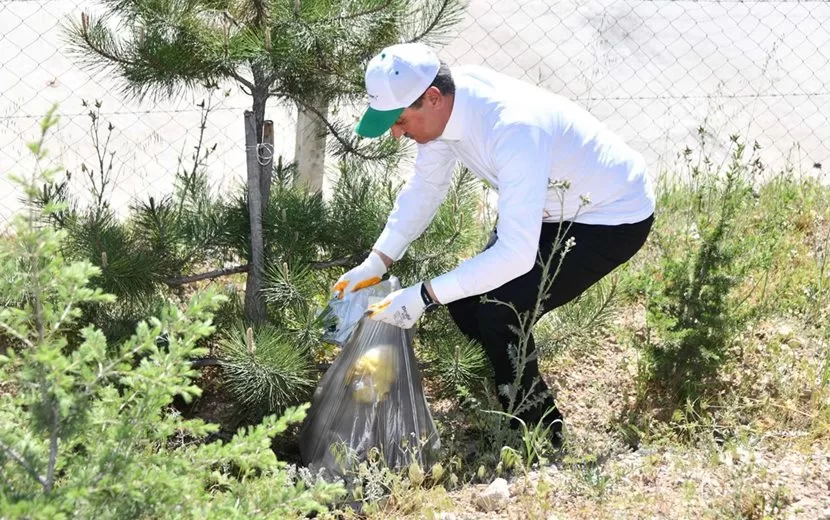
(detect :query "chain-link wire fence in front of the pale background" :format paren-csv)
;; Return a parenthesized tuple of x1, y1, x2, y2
(0, 0, 830, 221)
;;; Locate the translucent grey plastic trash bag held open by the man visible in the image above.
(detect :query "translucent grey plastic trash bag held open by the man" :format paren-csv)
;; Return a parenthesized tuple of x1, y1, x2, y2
(300, 278, 440, 476)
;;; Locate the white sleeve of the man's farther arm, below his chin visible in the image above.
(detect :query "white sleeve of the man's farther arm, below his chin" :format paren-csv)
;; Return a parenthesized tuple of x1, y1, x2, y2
(374, 141, 455, 260)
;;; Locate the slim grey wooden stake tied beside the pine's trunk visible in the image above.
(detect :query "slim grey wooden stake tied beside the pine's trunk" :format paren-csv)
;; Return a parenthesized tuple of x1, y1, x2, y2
(245, 110, 266, 324)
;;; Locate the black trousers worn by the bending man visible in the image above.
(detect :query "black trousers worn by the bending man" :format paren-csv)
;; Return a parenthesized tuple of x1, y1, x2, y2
(447, 216, 654, 431)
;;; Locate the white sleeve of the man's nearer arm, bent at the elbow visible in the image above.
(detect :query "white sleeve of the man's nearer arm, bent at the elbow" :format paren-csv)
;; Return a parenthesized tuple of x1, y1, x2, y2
(432, 124, 554, 303)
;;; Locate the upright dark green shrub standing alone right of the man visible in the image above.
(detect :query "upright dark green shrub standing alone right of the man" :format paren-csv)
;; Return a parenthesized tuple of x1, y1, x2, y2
(641, 136, 758, 403)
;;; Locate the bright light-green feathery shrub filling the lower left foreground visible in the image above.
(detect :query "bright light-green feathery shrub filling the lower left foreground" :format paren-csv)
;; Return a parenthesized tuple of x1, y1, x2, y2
(0, 108, 342, 519)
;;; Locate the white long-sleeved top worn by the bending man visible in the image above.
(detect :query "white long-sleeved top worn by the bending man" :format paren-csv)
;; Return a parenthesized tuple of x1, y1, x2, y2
(374, 67, 655, 303)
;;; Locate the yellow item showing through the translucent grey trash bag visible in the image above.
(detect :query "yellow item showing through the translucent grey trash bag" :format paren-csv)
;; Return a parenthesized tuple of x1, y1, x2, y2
(344, 345, 398, 403)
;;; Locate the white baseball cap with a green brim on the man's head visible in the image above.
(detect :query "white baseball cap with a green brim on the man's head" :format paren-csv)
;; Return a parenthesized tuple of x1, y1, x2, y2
(355, 43, 441, 137)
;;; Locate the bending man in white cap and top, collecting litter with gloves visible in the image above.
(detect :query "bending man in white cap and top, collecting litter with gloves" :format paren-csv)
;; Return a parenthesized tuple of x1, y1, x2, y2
(334, 44, 655, 440)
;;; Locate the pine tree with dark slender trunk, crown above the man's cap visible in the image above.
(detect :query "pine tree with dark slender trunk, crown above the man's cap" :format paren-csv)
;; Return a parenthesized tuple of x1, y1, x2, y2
(63, 0, 468, 322)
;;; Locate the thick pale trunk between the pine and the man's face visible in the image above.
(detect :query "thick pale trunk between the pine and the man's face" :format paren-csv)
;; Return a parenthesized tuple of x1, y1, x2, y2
(294, 96, 328, 193)
